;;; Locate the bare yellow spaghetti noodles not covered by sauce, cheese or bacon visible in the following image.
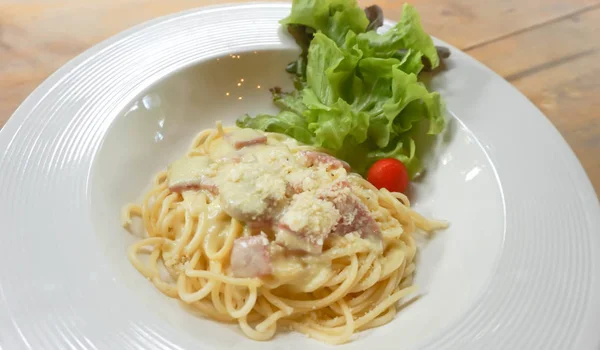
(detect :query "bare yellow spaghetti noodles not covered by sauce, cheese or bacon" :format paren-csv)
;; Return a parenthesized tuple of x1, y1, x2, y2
(122, 123, 446, 344)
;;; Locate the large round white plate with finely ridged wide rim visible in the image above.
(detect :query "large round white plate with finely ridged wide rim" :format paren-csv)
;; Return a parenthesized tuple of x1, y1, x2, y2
(0, 4, 600, 349)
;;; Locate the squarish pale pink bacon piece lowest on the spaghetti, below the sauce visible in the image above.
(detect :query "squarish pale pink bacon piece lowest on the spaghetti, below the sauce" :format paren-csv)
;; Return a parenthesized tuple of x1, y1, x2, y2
(230, 236, 273, 278)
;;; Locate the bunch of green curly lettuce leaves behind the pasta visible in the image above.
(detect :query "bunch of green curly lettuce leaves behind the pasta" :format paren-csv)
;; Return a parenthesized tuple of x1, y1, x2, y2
(237, 0, 445, 177)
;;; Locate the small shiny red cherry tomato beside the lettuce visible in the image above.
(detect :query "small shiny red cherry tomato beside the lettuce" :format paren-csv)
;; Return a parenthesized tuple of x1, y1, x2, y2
(367, 158, 408, 193)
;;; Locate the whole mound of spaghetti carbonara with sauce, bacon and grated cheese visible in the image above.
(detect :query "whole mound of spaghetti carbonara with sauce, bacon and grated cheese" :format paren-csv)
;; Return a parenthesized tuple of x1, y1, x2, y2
(122, 123, 445, 344)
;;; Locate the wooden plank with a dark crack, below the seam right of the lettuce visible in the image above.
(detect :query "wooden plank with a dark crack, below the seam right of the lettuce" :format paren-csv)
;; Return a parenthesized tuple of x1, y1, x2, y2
(469, 8, 600, 193)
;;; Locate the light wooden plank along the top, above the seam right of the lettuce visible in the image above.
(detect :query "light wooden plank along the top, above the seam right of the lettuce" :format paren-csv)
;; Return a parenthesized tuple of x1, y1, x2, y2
(0, 0, 600, 126)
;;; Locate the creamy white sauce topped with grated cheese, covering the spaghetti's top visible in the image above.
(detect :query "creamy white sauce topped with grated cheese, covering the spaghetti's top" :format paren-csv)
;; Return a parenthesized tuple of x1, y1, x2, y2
(168, 129, 379, 284)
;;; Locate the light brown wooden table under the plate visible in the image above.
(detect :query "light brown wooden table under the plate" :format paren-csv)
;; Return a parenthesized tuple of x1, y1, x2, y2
(0, 0, 600, 193)
